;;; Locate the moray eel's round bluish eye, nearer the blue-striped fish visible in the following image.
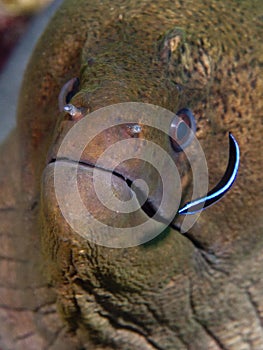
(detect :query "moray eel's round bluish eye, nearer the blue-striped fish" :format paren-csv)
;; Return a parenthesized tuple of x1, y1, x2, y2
(170, 108, 196, 152)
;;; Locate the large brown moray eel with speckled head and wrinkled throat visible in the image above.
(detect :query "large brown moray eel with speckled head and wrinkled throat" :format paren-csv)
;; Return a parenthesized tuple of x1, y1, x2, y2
(1, 0, 263, 350)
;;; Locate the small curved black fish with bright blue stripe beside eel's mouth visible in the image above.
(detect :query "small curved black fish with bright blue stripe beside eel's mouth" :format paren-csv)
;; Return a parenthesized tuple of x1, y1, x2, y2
(178, 133, 240, 215)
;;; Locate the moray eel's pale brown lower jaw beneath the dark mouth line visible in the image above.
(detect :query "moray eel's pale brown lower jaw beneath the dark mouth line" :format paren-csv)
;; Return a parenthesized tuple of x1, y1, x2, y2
(41, 153, 184, 248)
